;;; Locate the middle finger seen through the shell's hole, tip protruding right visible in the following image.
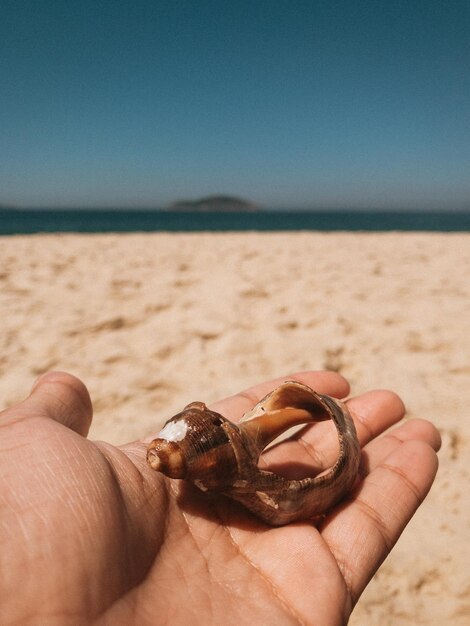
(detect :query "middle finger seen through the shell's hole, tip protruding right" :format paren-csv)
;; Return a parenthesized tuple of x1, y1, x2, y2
(264, 390, 405, 470)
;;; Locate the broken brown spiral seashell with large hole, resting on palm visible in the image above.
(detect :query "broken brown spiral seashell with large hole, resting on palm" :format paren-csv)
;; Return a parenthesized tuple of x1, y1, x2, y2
(147, 381, 360, 526)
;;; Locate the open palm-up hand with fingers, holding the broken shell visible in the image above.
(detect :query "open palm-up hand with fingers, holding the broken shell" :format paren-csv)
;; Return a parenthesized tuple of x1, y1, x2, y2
(0, 372, 440, 626)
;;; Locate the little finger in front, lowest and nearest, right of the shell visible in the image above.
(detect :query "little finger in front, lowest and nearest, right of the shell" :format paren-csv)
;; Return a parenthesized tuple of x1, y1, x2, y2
(319, 440, 438, 604)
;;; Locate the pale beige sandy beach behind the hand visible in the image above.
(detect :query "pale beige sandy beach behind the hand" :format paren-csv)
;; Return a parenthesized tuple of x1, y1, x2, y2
(0, 233, 470, 626)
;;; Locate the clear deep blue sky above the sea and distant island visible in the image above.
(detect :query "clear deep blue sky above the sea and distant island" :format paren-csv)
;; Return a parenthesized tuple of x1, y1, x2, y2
(0, 0, 470, 209)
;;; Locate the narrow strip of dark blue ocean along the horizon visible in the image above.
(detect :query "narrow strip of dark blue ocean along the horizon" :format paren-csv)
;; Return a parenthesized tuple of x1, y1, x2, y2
(0, 209, 470, 235)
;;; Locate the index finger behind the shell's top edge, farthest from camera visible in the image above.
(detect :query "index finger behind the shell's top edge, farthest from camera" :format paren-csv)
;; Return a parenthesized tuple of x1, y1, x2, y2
(211, 372, 349, 420)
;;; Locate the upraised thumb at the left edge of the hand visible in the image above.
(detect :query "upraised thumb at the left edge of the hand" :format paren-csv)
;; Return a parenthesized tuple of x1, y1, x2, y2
(2, 372, 93, 436)
